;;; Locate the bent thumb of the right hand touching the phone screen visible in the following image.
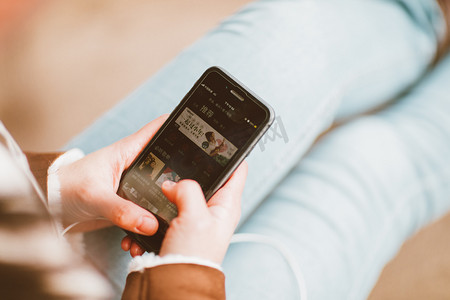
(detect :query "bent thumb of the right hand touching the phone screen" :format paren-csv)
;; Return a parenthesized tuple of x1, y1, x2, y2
(162, 180, 207, 215)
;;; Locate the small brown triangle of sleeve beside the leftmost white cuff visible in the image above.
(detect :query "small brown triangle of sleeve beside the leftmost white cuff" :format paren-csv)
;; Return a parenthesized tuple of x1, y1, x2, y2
(25, 152, 64, 196)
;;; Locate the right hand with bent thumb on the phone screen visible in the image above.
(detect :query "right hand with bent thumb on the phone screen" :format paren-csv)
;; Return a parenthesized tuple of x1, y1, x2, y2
(122, 162, 247, 264)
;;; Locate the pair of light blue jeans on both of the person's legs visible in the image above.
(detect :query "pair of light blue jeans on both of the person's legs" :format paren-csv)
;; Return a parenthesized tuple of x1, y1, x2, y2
(67, 0, 450, 300)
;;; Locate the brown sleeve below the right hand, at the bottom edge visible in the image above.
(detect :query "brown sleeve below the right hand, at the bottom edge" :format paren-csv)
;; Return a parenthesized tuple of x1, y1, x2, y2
(122, 264, 225, 300)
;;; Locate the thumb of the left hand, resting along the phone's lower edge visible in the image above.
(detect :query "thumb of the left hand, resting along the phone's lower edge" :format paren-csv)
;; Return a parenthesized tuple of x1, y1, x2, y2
(98, 194, 158, 235)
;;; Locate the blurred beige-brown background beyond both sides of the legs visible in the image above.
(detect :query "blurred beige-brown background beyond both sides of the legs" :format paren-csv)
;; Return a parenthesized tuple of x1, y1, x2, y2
(0, 0, 450, 300)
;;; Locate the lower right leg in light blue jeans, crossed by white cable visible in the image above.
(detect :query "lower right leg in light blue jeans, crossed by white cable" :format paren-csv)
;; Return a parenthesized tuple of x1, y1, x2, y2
(225, 56, 450, 300)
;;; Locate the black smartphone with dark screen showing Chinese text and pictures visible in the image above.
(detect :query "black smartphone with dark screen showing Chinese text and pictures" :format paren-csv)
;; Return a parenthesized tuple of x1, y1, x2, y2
(117, 67, 274, 253)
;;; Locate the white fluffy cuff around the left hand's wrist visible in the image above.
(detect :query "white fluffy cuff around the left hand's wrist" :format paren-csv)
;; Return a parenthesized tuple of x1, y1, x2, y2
(47, 148, 84, 216)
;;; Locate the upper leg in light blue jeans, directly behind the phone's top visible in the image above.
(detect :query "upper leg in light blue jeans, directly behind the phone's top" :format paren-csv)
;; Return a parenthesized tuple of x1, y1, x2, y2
(68, 0, 440, 296)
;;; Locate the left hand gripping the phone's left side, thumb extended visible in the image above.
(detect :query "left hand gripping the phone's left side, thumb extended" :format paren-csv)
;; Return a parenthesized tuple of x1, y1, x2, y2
(57, 115, 167, 235)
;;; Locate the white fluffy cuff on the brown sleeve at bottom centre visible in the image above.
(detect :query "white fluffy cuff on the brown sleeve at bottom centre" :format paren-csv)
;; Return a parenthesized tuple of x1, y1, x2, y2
(128, 252, 223, 273)
